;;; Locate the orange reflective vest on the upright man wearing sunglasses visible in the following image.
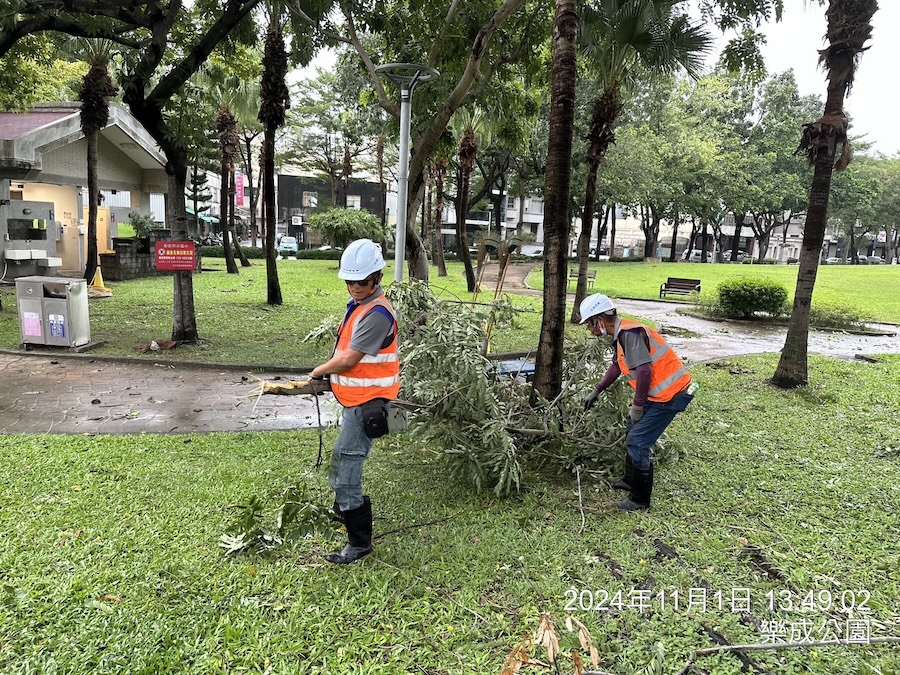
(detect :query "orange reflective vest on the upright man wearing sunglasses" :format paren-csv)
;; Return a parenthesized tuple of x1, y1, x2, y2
(331, 295, 400, 408)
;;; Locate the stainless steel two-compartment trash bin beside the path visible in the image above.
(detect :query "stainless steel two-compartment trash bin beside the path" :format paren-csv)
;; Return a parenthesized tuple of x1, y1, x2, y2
(16, 276, 91, 347)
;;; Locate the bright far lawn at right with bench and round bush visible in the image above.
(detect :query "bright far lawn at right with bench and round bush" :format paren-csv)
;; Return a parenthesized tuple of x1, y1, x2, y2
(528, 262, 900, 323)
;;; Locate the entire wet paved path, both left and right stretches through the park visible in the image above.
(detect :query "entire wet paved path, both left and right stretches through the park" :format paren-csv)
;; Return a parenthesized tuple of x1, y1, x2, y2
(0, 265, 900, 434)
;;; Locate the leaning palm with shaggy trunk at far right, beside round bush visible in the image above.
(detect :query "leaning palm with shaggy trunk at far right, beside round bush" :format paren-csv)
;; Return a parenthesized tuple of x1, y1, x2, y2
(772, 0, 878, 388)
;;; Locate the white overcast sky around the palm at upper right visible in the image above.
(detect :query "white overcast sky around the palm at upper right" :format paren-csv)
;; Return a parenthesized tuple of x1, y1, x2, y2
(764, 0, 900, 155)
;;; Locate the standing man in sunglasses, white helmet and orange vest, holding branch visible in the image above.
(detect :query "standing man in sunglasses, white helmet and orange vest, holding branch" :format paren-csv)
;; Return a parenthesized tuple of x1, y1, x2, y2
(310, 239, 400, 565)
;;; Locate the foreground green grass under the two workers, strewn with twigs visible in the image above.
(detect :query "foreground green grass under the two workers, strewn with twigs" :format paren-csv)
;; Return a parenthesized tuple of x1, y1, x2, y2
(0, 356, 900, 675)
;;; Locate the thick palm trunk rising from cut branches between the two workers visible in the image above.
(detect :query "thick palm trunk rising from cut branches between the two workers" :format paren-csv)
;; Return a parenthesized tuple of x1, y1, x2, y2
(534, 0, 578, 401)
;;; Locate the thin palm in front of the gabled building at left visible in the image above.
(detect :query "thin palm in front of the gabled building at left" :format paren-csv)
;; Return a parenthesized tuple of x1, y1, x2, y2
(77, 39, 118, 284)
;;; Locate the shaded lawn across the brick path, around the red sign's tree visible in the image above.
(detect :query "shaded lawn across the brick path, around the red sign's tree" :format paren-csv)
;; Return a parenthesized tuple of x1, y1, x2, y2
(0, 258, 541, 366)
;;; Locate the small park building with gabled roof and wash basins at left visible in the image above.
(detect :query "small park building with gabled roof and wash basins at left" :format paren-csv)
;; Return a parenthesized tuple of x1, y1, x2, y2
(0, 103, 167, 278)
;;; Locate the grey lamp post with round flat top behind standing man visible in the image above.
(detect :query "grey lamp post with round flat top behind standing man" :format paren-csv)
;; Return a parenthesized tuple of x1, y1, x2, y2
(375, 63, 440, 281)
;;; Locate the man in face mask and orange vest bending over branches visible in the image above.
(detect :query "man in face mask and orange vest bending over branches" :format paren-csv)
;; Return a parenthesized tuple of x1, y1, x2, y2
(580, 293, 696, 511)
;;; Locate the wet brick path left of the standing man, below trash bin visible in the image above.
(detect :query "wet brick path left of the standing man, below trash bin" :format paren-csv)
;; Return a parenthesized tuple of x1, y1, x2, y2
(0, 352, 336, 434)
